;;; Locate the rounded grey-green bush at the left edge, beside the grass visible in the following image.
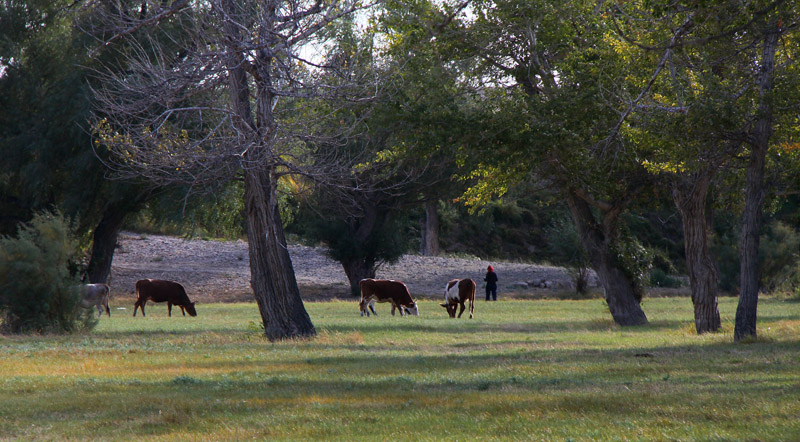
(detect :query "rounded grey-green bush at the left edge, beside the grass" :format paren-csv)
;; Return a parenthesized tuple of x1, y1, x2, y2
(0, 212, 97, 333)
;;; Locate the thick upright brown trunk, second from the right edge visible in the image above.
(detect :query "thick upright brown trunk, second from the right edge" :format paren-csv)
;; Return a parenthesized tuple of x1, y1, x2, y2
(672, 174, 722, 334)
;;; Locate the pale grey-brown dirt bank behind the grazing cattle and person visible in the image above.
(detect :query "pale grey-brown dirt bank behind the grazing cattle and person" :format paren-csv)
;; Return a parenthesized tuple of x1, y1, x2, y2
(111, 232, 597, 302)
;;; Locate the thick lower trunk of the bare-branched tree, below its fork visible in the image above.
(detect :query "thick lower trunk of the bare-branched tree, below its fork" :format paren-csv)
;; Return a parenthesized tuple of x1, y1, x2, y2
(245, 168, 316, 341)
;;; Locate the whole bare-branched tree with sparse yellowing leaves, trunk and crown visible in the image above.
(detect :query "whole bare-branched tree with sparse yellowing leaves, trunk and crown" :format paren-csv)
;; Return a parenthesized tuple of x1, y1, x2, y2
(87, 0, 376, 340)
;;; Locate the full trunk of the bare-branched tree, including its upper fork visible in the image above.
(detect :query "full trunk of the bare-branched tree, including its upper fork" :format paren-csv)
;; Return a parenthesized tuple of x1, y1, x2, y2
(221, 0, 316, 341)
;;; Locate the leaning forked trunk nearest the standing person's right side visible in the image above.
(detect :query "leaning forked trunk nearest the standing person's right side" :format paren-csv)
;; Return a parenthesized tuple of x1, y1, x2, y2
(567, 192, 647, 326)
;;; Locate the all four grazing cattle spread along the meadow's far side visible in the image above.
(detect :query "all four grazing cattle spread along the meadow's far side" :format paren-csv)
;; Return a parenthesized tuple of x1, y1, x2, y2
(81, 279, 475, 319)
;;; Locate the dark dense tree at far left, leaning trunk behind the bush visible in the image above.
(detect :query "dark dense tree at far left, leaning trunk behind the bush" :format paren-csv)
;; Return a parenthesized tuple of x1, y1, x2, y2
(0, 1, 150, 282)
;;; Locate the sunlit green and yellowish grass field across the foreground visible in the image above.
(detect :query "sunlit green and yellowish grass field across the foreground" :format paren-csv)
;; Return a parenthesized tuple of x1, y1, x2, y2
(0, 298, 800, 441)
